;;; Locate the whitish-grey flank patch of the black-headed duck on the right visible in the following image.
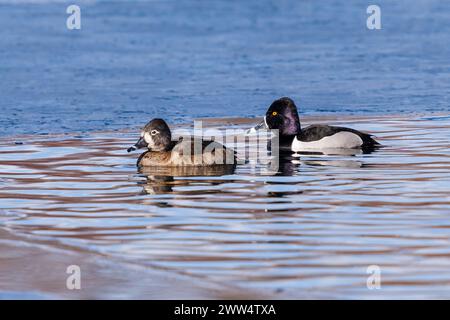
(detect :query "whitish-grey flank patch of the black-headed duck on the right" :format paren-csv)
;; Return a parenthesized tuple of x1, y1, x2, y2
(292, 131, 363, 151)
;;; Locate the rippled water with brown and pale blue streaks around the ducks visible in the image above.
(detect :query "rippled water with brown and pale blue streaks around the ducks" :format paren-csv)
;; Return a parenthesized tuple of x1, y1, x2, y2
(0, 116, 450, 298)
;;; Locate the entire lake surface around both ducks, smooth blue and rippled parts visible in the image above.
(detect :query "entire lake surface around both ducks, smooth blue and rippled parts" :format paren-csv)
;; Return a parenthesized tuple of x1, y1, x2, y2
(0, 0, 450, 298)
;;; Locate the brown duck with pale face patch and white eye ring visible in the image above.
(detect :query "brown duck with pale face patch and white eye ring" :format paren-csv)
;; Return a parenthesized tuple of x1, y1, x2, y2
(127, 119, 236, 167)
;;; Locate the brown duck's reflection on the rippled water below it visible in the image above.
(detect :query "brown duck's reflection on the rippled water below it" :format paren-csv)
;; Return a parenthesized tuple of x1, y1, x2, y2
(139, 165, 235, 194)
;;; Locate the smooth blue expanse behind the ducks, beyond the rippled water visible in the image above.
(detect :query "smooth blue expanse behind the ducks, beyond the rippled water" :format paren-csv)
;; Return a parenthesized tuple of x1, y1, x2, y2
(0, 0, 450, 136)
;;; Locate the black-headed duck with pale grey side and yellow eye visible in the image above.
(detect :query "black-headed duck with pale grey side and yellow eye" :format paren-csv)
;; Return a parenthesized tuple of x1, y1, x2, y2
(253, 97, 380, 152)
